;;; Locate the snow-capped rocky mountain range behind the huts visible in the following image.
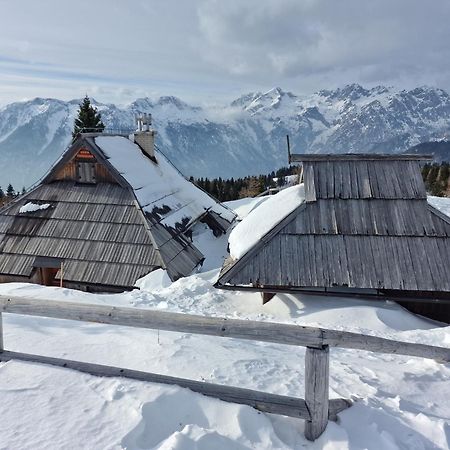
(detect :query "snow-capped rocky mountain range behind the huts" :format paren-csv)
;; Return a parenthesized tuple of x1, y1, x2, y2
(0, 84, 450, 188)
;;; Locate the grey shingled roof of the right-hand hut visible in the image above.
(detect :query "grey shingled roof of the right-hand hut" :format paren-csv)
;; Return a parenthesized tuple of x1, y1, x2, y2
(217, 155, 450, 292)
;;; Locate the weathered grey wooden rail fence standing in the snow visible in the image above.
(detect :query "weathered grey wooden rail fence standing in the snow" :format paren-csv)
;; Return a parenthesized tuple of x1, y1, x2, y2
(0, 296, 450, 440)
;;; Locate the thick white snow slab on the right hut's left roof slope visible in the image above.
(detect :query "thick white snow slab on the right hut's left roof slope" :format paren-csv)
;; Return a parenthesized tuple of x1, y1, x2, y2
(228, 184, 305, 259)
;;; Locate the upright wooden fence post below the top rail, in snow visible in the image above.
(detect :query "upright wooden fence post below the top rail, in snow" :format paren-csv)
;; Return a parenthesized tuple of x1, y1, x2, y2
(305, 345, 330, 441)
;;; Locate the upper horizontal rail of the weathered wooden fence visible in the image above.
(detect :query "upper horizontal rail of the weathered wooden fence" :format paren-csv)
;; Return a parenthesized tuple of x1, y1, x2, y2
(0, 296, 450, 362)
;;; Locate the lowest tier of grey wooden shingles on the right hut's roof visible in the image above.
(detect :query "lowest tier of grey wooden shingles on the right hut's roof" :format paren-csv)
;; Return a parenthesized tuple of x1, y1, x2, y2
(220, 234, 450, 291)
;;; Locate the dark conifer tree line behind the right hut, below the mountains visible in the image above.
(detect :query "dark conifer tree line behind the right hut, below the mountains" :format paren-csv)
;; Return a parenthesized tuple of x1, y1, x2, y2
(190, 162, 450, 202)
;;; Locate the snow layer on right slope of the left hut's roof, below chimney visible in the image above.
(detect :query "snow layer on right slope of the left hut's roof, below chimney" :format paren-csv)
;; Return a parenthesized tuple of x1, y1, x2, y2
(95, 136, 234, 227)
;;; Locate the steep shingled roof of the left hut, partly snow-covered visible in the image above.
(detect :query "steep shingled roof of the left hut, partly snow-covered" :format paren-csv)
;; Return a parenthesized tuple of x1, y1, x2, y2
(0, 135, 234, 288)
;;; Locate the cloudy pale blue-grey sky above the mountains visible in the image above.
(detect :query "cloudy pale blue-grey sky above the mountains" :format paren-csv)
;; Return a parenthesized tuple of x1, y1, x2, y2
(0, 0, 450, 105)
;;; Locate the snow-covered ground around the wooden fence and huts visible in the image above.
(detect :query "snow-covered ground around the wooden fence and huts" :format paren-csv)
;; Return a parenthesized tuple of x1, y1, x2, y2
(0, 200, 450, 450)
